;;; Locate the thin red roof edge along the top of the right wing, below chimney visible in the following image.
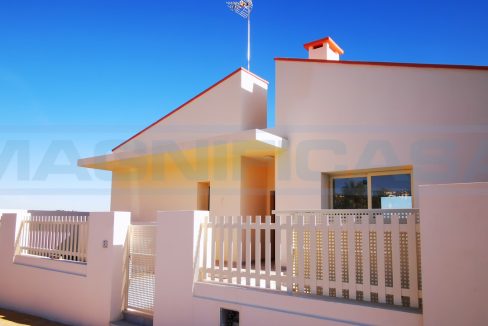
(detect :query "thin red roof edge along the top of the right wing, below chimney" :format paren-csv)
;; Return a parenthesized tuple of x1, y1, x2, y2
(275, 58, 488, 70)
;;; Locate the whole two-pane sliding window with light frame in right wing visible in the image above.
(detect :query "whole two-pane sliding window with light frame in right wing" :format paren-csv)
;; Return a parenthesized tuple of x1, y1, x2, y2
(330, 170, 413, 209)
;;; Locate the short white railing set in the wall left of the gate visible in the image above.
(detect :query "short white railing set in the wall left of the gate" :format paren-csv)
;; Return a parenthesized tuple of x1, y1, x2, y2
(16, 215, 88, 263)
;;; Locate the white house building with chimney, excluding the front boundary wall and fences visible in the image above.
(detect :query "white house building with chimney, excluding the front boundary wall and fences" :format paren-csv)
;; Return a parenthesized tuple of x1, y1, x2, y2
(80, 38, 488, 221)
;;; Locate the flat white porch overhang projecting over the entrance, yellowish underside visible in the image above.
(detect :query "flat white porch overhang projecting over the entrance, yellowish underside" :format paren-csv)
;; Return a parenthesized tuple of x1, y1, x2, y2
(78, 129, 288, 171)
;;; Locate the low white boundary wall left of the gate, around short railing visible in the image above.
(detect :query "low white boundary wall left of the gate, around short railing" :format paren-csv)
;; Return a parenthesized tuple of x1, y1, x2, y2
(0, 212, 130, 326)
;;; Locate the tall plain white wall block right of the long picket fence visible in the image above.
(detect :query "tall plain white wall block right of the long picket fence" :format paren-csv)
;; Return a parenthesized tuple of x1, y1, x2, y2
(420, 183, 488, 326)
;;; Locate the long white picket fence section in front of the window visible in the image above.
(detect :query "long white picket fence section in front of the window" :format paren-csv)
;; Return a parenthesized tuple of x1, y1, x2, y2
(200, 209, 422, 308)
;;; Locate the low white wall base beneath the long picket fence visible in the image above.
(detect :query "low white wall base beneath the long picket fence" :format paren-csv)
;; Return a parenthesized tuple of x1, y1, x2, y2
(194, 283, 422, 325)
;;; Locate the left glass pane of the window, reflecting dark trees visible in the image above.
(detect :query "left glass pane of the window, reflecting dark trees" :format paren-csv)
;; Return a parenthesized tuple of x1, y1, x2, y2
(332, 177, 368, 209)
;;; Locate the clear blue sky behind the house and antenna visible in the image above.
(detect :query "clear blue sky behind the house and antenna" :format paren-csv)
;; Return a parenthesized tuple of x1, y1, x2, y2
(0, 0, 488, 210)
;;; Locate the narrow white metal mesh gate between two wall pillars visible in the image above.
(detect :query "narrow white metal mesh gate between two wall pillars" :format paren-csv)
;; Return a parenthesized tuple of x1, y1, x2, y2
(127, 225, 156, 314)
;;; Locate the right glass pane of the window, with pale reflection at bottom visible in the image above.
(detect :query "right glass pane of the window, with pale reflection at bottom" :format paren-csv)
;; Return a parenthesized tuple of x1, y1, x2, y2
(371, 174, 412, 209)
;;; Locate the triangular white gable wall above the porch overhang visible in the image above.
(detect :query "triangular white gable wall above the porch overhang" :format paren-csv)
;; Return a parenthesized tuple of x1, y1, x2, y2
(116, 69, 268, 152)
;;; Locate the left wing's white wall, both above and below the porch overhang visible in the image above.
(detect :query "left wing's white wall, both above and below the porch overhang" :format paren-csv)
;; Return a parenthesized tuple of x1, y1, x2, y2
(107, 69, 268, 221)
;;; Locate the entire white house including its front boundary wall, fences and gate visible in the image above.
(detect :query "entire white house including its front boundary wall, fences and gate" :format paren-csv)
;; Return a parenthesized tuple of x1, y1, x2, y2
(0, 37, 488, 325)
